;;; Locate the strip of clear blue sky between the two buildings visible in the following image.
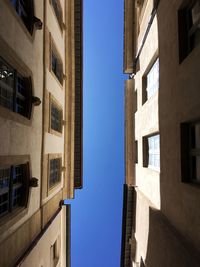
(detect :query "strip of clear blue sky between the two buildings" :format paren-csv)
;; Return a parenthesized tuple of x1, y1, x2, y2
(66, 0, 125, 267)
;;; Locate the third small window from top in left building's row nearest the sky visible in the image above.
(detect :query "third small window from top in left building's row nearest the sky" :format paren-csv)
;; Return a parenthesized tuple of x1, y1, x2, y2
(50, 99, 63, 133)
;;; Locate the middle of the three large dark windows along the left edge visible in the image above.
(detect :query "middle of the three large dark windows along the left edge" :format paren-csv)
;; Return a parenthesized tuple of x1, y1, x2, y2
(0, 57, 32, 119)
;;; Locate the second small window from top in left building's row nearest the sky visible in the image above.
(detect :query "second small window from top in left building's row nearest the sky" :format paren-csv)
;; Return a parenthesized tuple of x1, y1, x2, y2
(50, 42, 63, 85)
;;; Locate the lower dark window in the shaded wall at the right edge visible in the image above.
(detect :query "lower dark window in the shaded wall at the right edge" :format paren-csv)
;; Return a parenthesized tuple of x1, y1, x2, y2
(181, 121, 200, 183)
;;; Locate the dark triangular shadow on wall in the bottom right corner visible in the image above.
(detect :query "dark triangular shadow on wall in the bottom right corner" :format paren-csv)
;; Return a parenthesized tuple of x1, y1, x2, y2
(145, 208, 199, 267)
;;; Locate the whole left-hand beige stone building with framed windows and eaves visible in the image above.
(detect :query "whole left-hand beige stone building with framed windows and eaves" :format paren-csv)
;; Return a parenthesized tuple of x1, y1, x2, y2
(0, 0, 82, 267)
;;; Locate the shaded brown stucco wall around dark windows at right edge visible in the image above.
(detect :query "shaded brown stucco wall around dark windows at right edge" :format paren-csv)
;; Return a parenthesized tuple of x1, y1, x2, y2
(158, 0, 200, 251)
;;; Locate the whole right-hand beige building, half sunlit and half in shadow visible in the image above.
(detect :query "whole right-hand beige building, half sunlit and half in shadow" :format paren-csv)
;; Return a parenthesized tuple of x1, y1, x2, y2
(121, 0, 200, 267)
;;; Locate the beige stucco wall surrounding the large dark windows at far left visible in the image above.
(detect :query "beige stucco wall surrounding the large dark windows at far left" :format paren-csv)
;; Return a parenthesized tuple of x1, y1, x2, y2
(0, 0, 43, 243)
